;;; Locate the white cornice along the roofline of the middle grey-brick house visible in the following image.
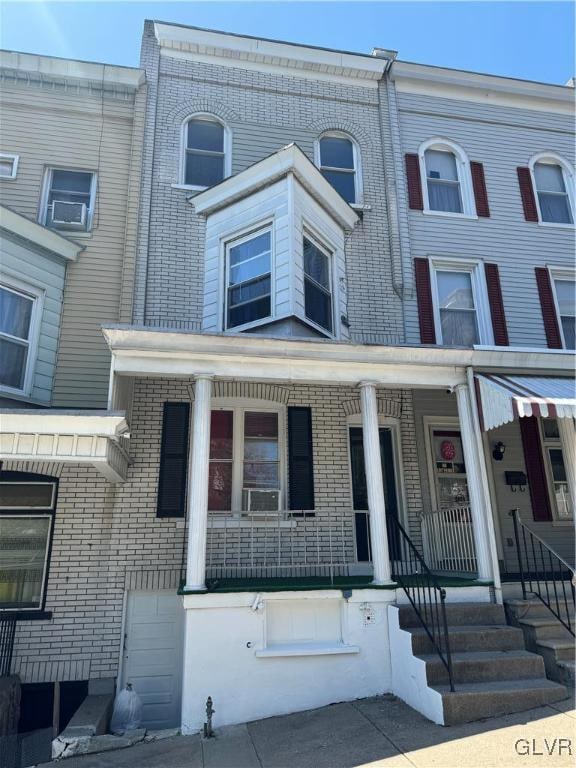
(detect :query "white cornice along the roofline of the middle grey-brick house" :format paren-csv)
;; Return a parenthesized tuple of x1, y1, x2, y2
(154, 22, 389, 88)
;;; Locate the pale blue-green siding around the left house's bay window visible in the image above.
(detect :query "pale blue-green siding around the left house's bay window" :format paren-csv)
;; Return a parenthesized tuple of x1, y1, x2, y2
(0, 231, 66, 408)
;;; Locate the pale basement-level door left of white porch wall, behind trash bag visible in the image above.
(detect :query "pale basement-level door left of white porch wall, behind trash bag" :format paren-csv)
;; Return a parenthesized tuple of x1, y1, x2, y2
(122, 591, 184, 729)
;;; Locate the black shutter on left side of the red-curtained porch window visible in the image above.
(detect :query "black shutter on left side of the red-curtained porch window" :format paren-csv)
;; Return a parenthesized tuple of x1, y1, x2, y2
(156, 403, 190, 517)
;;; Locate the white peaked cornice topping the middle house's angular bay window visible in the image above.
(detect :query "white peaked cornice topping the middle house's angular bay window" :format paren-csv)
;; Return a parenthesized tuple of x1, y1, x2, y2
(190, 144, 359, 231)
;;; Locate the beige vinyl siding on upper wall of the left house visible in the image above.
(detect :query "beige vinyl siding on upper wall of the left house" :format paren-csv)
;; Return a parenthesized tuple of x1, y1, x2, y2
(0, 73, 142, 408)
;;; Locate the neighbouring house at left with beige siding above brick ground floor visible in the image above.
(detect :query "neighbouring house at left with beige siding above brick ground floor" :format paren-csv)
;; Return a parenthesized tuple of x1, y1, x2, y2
(0, 51, 146, 719)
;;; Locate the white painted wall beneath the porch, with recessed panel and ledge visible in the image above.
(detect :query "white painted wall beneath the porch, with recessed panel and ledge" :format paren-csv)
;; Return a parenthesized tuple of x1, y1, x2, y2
(182, 590, 396, 734)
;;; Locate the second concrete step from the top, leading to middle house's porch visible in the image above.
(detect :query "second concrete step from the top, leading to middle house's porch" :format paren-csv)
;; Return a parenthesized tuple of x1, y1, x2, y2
(406, 624, 525, 656)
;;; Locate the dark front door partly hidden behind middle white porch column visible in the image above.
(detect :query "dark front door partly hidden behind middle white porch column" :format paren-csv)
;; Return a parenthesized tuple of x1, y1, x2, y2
(350, 427, 400, 562)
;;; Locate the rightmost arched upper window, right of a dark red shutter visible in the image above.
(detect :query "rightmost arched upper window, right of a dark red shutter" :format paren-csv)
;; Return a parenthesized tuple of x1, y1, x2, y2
(530, 155, 574, 224)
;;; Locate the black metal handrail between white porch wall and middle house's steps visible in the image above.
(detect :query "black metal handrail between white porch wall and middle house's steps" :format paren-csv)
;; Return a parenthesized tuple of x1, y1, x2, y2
(387, 515, 454, 691)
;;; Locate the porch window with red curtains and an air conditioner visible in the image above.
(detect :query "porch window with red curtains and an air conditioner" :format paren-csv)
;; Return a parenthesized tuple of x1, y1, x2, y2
(208, 407, 282, 512)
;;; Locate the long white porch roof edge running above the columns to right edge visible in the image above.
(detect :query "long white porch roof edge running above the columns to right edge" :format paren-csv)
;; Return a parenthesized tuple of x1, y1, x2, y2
(103, 325, 575, 388)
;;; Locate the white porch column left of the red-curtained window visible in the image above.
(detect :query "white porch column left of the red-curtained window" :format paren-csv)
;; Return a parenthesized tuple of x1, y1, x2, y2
(186, 376, 212, 590)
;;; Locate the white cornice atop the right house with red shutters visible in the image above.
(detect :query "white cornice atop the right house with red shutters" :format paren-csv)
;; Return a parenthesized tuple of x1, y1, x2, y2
(390, 61, 574, 115)
